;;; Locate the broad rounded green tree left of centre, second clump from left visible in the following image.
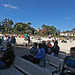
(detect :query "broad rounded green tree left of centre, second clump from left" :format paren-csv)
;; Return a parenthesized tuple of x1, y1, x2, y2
(13, 22, 34, 34)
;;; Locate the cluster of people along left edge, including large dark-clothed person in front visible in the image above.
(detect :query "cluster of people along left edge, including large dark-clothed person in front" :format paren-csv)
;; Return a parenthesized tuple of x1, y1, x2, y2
(0, 36, 16, 69)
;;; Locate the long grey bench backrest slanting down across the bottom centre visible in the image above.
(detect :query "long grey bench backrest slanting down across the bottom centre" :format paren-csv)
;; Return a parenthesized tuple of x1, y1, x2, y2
(14, 56, 52, 75)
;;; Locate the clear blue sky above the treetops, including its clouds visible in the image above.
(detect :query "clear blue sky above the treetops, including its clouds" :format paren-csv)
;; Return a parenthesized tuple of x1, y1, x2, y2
(0, 0, 75, 32)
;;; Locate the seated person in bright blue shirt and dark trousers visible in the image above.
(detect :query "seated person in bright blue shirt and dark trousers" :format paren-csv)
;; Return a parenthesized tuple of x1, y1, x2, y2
(30, 43, 45, 64)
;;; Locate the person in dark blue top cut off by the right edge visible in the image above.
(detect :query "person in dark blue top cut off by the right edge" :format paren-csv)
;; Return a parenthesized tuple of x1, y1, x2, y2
(64, 47, 75, 75)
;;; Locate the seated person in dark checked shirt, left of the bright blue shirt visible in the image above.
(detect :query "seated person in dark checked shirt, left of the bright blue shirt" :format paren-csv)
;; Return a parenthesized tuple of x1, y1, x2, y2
(22, 43, 38, 60)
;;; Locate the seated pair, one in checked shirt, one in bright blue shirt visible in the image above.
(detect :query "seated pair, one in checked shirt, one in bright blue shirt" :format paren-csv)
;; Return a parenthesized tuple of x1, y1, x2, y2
(22, 43, 45, 64)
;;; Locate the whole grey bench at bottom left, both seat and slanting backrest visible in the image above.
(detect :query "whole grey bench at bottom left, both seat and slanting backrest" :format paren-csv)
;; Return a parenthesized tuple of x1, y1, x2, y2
(0, 56, 52, 75)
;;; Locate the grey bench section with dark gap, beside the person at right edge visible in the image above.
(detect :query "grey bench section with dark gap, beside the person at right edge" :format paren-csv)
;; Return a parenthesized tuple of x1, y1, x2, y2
(45, 54, 64, 74)
